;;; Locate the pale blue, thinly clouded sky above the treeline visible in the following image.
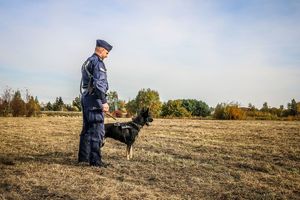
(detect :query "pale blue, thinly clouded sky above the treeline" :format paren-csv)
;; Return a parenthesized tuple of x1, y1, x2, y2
(0, 0, 300, 107)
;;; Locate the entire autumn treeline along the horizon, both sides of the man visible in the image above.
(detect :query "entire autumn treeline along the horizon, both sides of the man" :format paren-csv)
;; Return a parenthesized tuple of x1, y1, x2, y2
(0, 88, 300, 120)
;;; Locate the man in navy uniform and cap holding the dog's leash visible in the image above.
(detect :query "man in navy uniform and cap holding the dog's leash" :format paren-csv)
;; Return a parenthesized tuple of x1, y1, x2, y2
(78, 40, 112, 167)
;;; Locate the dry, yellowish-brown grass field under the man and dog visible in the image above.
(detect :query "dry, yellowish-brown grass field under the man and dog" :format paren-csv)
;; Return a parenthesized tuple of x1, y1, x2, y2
(0, 117, 300, 199)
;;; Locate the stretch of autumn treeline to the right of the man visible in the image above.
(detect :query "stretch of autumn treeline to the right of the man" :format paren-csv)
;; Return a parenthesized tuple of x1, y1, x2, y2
(109, 89, 300, 120)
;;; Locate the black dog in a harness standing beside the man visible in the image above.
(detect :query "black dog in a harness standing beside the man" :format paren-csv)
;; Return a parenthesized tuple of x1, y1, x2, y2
(102, 108, 153, 160)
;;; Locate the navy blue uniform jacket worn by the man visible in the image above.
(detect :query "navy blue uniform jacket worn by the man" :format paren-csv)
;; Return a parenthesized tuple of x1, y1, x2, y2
(82, 53, 108, 104)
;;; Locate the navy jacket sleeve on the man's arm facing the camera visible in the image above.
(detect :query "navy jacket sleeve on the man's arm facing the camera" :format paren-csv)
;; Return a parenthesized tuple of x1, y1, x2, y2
(93, 63, 107, 104)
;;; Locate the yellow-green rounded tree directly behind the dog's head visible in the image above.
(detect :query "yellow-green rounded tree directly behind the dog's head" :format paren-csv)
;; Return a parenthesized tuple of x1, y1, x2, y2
(135, 88, 162, 117)
